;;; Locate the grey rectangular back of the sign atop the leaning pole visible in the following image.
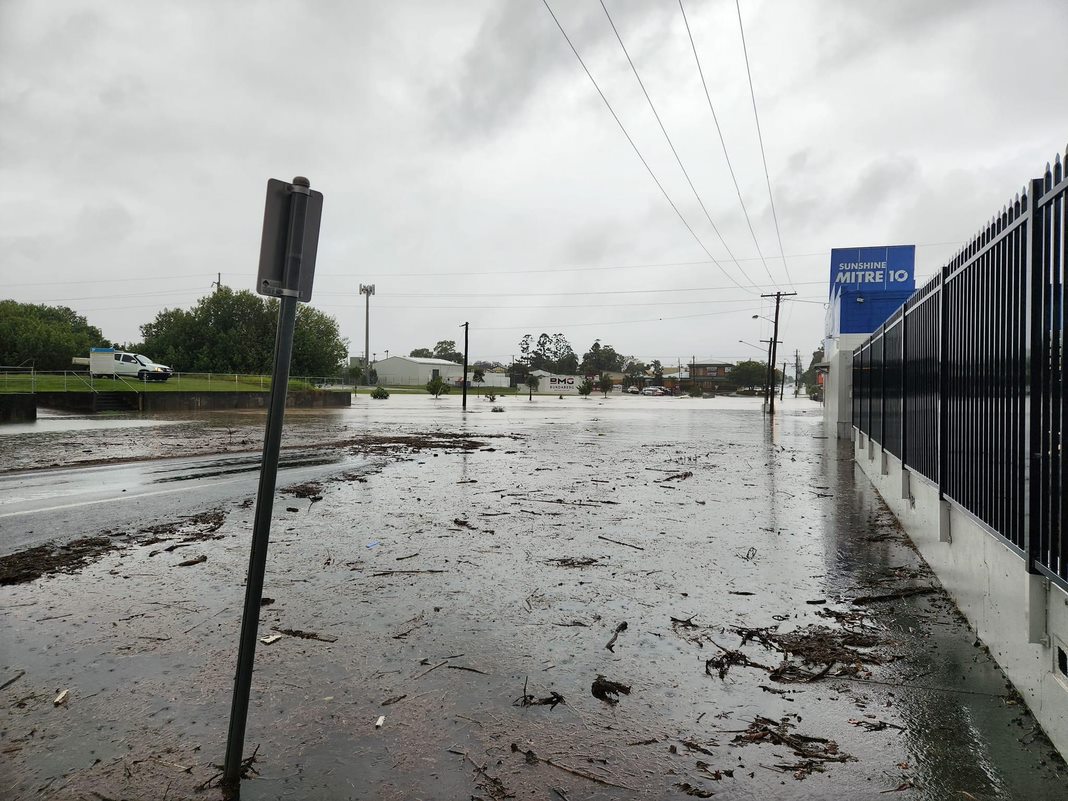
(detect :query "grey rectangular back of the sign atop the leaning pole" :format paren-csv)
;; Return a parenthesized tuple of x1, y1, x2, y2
(256, 178, 323, 303)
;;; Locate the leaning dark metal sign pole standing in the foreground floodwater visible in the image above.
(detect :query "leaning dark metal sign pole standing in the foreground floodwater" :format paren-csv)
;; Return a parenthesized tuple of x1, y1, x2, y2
(222, 177, 321, 797)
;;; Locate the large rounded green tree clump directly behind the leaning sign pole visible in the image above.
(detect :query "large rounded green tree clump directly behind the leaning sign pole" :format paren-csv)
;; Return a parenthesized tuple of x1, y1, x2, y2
(138, 286, 348, 376)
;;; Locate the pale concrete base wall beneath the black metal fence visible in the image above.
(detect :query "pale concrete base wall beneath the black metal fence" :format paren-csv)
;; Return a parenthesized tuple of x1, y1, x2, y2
(853, 429, 1068, 755)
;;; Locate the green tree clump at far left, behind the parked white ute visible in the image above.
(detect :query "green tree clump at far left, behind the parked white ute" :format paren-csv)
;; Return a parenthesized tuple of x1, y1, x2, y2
(0, 300, 110, 370)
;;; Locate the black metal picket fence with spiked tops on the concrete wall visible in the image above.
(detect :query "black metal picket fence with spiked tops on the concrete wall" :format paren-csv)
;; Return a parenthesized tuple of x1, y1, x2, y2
(852, 149, 1068, 587)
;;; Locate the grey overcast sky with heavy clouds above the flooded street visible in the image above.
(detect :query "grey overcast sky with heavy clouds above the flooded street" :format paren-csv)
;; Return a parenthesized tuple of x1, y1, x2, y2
(0, 0, 1068, 370)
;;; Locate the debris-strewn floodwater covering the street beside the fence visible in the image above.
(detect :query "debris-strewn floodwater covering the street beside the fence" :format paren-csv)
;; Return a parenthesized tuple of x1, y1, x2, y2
(0, 395, 1068, 801)
